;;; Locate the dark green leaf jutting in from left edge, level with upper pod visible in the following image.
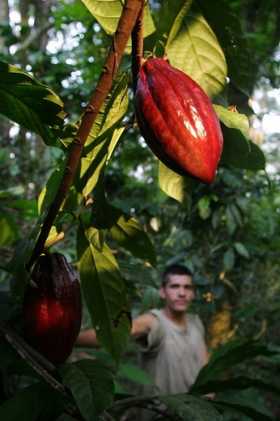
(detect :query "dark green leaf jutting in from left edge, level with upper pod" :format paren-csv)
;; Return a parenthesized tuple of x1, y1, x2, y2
(0, 62, 65, 144)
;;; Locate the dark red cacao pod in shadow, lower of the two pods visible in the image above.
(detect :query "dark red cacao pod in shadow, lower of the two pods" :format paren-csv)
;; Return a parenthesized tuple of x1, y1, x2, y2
(23, 253, 82, 364)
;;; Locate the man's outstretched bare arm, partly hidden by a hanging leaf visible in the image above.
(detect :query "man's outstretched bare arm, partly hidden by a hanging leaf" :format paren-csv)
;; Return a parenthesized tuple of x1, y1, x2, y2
(75, 313, 156, 348)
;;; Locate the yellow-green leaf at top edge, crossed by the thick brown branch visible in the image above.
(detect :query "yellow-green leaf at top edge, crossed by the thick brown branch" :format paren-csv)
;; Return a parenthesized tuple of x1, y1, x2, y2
(82, 0, 155, 37)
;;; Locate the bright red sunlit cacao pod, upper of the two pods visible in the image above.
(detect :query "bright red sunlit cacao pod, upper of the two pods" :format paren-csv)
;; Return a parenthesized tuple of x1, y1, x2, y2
(135, 58, 223, 183)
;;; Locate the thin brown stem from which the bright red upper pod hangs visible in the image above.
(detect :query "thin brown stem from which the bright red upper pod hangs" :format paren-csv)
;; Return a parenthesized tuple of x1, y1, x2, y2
(131, 1, 144, 92)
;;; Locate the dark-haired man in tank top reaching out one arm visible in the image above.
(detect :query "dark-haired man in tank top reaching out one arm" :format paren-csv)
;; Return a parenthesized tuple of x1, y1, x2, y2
(77, 265, 208, 394)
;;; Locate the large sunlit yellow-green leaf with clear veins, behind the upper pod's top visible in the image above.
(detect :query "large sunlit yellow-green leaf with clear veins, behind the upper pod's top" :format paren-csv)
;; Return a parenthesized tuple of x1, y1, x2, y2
(165, 1, 227, 97)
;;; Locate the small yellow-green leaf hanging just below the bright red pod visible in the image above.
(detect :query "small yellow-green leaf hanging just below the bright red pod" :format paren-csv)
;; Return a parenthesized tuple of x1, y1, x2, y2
(158, 161, 190, 203)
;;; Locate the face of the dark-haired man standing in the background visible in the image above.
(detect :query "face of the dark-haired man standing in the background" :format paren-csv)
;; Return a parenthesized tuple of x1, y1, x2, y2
(160, 275, 194, 312)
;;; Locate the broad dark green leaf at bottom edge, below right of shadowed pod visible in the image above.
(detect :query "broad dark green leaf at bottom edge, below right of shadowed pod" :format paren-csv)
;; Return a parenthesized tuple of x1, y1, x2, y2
(60, 360, 114, 421)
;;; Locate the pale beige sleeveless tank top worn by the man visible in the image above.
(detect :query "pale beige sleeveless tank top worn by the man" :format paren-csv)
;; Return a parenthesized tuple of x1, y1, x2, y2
(141, 310, 206, 394)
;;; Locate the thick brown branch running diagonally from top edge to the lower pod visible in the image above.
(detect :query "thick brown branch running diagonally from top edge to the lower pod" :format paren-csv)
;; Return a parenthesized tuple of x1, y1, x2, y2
(26, 0, 142, 270)
